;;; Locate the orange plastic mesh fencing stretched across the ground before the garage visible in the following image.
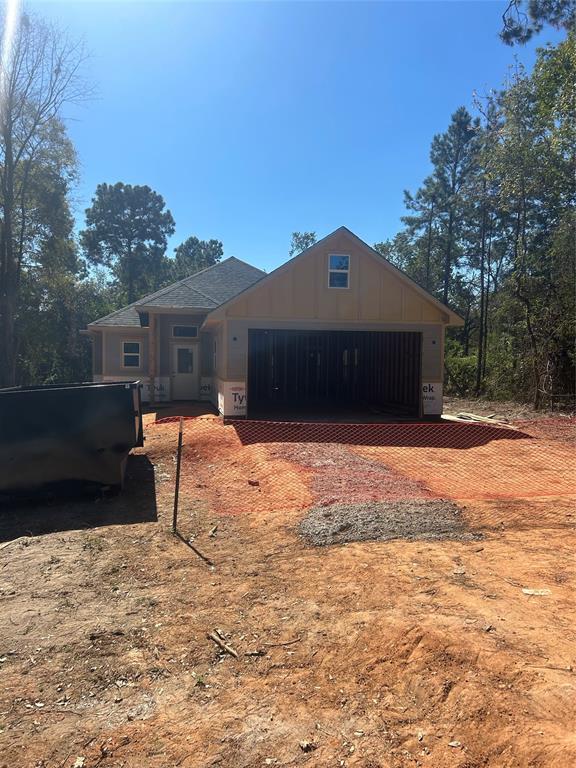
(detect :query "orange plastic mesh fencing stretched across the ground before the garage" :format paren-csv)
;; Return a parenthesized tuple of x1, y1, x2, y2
(151, 417, 576, 504)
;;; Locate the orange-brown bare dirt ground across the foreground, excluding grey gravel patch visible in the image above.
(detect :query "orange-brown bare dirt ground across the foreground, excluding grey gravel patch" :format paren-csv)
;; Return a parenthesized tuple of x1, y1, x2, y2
(0, 407, 576, 768)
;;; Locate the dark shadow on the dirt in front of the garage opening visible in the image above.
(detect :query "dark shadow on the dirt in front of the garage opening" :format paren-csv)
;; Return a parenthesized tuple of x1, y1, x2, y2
(226, 420, 533, 449)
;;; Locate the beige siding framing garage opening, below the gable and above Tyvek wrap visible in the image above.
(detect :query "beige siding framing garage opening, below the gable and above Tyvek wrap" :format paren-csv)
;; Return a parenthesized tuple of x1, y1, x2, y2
(219, 319, 444, 382)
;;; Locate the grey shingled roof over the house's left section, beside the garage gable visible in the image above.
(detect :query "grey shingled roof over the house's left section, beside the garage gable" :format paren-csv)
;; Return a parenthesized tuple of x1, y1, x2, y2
(89, 256, 266, 328)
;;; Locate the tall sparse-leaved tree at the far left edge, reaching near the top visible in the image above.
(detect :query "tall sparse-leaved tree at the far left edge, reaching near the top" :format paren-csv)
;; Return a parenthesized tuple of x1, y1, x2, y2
(0, 9, 86, 386)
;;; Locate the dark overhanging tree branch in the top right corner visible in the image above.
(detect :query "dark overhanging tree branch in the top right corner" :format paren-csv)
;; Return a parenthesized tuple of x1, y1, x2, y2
(500, 0, 576, 45)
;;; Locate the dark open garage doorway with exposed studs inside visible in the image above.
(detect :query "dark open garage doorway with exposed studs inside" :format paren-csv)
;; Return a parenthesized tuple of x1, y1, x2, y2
(248, 329, 422, 418)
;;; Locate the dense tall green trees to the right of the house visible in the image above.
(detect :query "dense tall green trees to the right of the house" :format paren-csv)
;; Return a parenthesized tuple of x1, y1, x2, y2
(390, 33, 576, 407)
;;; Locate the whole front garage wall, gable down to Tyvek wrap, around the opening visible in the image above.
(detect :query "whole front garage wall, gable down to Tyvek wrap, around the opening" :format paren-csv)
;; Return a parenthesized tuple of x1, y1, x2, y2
(209, 232, 449, 416)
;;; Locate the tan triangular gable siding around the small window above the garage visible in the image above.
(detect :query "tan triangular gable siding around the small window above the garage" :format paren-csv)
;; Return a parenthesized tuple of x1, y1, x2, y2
(226, 228, 447, 323)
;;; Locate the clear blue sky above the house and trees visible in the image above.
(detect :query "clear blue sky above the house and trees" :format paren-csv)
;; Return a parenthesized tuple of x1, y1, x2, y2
(29, 0, 559, 270)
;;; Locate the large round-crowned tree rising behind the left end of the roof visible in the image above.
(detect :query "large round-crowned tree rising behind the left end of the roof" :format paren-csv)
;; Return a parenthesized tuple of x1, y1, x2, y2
(80, 182, 175, 304)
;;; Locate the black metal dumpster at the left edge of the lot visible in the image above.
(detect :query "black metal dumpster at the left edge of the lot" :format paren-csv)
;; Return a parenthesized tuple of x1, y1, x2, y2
(0, 381, 143, 494)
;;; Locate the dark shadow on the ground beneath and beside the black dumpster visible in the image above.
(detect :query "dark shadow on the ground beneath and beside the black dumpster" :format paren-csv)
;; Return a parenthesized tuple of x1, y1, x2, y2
(0, 455, 157, 541)
